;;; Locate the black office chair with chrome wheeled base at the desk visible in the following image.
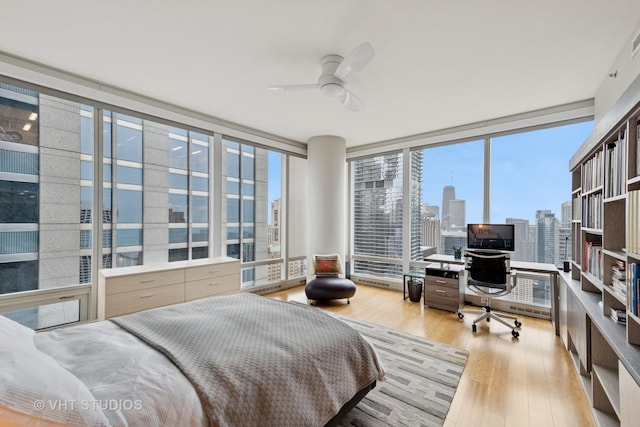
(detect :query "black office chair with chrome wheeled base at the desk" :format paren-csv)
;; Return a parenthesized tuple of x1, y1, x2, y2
(458, 250, 522, 338)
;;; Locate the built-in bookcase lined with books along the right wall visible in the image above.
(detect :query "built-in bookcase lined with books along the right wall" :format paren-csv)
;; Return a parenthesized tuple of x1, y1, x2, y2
(560, 76, 640, 427)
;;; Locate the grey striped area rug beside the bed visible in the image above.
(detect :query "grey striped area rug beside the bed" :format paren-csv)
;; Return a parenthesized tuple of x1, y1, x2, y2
(333, 314, 469, 427)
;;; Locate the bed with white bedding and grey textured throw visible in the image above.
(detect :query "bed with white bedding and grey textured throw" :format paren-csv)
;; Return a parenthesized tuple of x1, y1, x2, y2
(0, 294, 384, 426)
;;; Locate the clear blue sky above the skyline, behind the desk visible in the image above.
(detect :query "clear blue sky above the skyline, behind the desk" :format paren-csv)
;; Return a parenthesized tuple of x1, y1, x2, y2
(422, 121, 593, 223)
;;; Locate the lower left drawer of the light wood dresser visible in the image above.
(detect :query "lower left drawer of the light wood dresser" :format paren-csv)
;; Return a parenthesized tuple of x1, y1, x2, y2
(105, 283, 184, 318)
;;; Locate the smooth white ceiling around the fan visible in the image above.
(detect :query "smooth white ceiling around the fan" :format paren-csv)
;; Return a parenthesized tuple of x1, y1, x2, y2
(0, 0, 640, 147)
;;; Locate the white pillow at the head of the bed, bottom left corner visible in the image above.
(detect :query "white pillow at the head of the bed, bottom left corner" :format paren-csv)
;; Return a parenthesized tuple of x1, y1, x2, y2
(0, 315, 109, 426)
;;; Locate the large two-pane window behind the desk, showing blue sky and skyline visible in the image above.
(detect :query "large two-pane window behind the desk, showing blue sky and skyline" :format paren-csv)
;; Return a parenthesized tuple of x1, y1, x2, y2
(408, 121, 593, 314)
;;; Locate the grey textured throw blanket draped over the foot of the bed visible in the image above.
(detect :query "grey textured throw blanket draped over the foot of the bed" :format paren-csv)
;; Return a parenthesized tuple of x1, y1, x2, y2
(111, 294, 384, 426)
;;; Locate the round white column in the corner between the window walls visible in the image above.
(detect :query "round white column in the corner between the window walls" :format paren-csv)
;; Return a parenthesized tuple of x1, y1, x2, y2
(308, 135, 347, 275)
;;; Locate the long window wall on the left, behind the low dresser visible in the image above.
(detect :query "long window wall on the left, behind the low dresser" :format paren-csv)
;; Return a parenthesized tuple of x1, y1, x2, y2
(0, 78, 306, 329)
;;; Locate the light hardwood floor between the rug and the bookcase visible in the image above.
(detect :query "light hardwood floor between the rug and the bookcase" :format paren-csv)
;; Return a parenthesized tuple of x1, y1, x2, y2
(265, 285, 595, 427)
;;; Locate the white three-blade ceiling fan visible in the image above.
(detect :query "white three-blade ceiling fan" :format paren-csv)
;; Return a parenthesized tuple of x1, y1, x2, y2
(269, 43, 375, 111)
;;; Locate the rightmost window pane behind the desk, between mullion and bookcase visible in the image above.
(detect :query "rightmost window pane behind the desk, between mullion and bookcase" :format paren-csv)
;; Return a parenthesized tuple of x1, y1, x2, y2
(491, 121, 593, 266)
